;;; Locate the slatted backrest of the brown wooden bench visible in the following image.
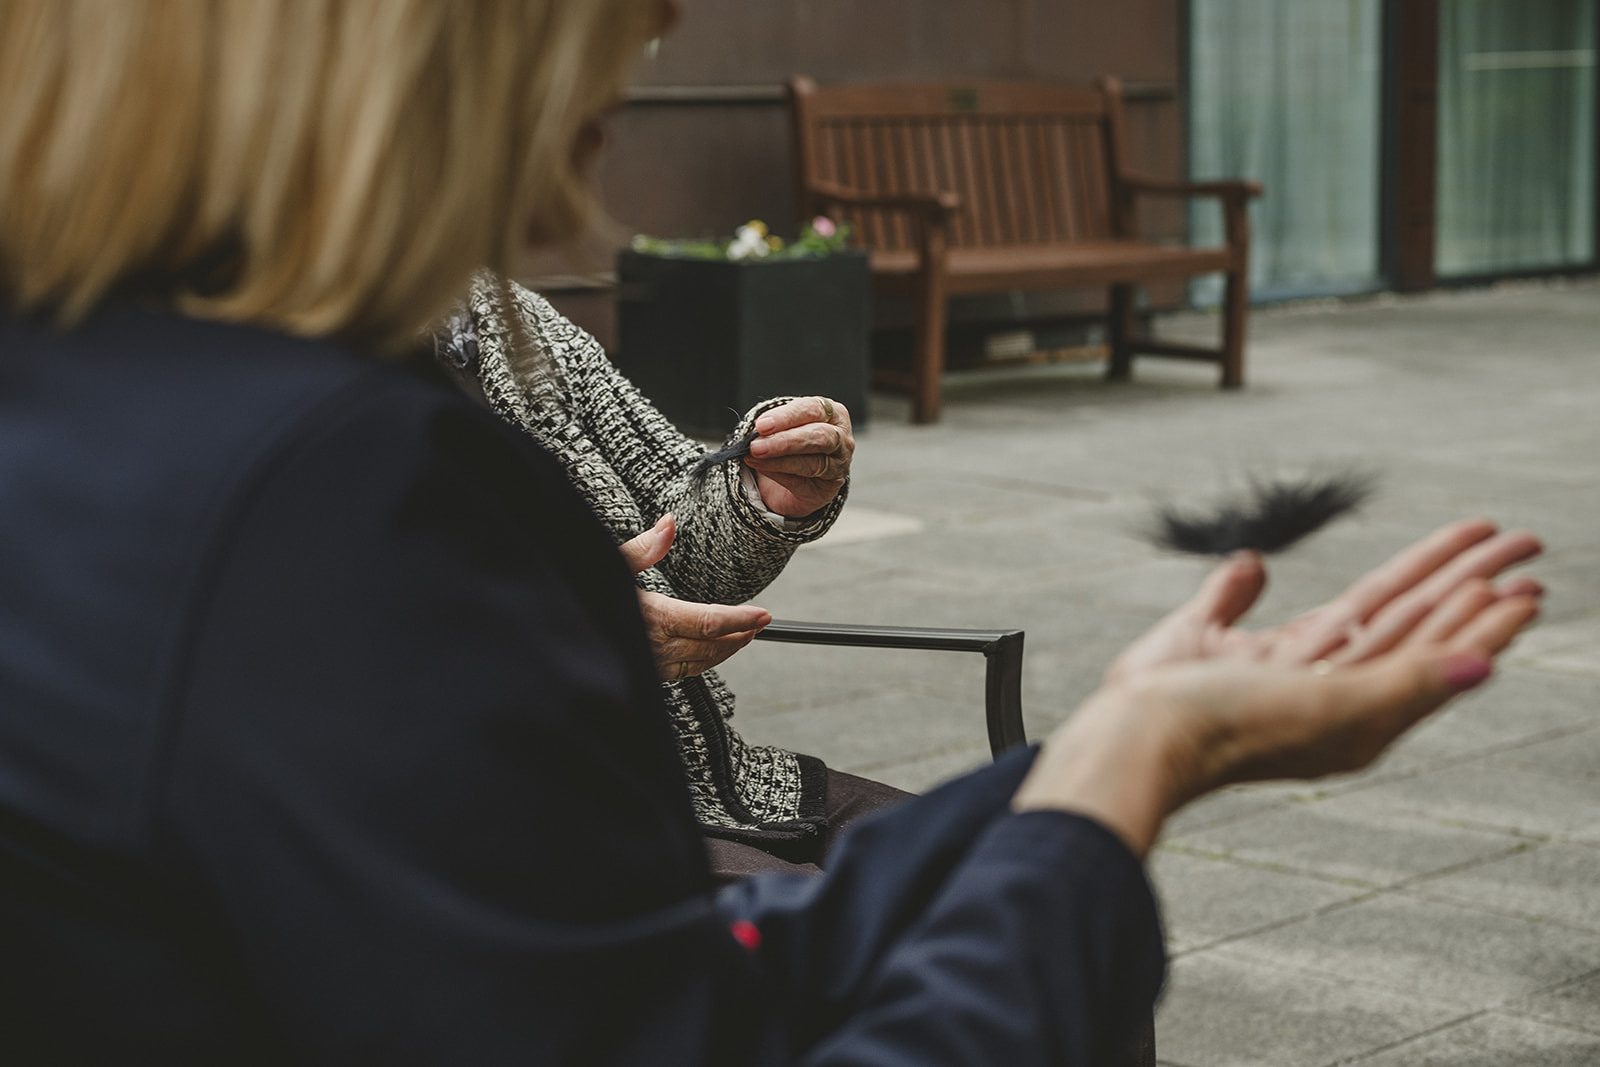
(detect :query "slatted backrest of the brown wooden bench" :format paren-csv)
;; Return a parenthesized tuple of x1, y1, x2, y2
(792, 78, 1120, 250)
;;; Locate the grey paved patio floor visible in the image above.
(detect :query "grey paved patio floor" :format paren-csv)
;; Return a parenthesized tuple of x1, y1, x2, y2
(723, 280, 1600, 1067)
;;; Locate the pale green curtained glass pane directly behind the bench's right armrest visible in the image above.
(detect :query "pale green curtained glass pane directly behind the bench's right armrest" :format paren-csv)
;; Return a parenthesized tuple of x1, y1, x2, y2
(1189, 0, 1382, 302)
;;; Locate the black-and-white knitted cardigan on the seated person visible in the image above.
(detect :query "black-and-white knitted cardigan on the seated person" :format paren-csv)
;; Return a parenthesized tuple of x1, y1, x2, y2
(437, 275, 848, 856)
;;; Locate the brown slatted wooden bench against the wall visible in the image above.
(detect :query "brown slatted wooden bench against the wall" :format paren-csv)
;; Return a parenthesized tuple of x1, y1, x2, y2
(789, 77, 1261, 422)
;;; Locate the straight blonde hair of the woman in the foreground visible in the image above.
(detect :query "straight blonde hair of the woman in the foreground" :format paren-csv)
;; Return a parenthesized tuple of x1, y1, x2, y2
(0, 0, 659, 349)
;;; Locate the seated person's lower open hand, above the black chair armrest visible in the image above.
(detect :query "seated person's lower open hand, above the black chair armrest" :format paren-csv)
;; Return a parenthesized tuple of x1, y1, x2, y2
(621, 514, 773, 681)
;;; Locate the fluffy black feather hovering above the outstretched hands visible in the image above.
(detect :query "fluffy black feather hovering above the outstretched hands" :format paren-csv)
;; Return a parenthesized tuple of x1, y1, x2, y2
(1149, 470, 1376, 555)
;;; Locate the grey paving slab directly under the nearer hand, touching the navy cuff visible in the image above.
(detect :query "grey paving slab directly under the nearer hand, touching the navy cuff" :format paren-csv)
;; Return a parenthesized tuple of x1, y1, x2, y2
(1168, 797, 1523, 886)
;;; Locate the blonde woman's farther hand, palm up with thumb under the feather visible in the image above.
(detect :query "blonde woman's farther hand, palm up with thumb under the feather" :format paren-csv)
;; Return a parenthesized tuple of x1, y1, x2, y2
(1106, 520, 1544, 683)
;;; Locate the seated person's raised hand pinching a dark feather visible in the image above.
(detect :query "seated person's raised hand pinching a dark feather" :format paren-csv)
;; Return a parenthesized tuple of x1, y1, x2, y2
(744, 397, 856, 518)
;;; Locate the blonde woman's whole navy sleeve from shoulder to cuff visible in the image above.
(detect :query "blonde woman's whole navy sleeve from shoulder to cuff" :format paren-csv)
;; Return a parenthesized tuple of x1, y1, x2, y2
(150, 375, 1160, 1064)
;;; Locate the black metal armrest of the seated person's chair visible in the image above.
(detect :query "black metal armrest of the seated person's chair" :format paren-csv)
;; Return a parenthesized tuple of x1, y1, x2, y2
(755, 619, 1027, 757)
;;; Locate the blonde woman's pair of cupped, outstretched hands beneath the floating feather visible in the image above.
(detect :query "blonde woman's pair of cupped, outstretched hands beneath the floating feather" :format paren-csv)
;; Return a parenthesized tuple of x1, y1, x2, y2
(1013, 522, 1542, 856)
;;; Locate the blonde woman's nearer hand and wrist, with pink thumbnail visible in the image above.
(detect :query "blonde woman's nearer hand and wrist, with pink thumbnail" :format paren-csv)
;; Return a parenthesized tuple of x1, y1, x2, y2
(1013, 571, 1539, 856)
